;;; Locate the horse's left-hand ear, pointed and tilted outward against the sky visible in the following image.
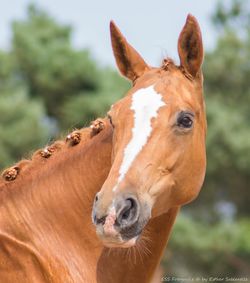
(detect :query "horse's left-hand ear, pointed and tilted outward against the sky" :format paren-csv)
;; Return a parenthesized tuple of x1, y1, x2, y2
(110, 21, 149, 81)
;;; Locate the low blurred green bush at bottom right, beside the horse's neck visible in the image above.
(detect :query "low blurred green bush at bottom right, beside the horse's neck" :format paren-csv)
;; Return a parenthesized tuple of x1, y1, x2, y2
(163, 215, 250, 281)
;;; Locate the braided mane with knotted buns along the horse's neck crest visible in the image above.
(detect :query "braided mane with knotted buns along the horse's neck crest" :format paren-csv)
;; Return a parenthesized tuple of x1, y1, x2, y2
(0, 118, 108, 192)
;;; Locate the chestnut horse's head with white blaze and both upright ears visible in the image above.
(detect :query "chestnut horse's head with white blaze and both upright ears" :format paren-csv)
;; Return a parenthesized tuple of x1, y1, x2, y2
(92, 12, 207, 272)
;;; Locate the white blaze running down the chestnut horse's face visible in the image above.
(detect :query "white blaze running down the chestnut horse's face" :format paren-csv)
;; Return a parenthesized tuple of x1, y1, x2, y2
(113, 86, 165, 191)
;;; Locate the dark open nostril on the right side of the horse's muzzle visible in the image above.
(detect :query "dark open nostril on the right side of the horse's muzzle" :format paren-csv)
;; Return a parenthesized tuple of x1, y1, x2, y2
(116, 198, 138, 225)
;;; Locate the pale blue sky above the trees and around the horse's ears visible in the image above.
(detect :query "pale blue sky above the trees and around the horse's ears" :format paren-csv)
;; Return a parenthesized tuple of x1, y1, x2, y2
(0, 0, 223, 66)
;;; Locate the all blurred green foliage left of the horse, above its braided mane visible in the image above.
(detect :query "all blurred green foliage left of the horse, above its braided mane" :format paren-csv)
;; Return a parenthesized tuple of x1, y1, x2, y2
(0, 4, 129, 169)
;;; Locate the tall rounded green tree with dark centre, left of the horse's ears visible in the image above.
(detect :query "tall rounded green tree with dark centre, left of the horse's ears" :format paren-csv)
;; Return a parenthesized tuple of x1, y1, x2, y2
(13, 5, 128, 129)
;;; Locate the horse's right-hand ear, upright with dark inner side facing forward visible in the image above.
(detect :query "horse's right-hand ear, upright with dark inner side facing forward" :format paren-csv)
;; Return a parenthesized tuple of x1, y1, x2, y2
(178, 14, 203, 77)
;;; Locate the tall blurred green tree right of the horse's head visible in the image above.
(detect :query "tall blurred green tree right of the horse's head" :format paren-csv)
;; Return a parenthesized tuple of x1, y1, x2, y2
(188, 1, 250, 222)
